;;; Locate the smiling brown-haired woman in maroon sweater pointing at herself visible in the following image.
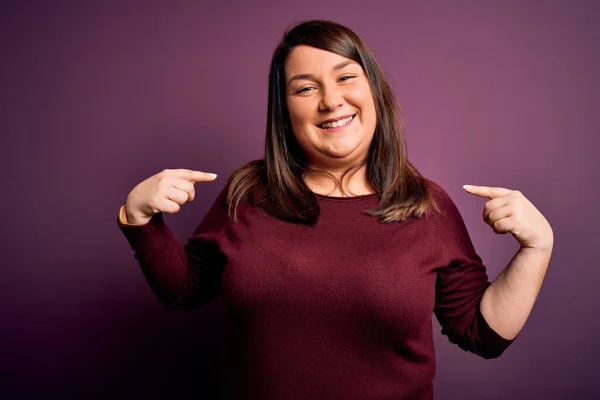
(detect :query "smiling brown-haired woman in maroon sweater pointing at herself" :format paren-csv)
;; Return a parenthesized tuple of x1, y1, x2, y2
(118, 21, 553, 399)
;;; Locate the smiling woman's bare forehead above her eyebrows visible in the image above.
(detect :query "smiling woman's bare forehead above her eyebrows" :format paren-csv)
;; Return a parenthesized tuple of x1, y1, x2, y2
(285, 45, 358, 76)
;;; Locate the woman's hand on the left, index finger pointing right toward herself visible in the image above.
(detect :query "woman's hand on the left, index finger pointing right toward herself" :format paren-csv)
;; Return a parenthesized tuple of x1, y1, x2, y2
(125, 169, 217, 225)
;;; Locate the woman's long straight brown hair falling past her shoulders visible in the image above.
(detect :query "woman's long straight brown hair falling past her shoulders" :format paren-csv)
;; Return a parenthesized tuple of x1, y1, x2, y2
(227, 20, 439, 225)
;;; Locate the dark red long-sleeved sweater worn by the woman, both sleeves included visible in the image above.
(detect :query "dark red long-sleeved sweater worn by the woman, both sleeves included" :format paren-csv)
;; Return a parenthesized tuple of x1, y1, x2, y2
(117, 182, 512, 400)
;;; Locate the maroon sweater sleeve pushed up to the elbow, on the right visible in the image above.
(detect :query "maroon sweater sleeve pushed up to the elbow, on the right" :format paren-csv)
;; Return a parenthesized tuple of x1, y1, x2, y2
(431, 184, 515, 358)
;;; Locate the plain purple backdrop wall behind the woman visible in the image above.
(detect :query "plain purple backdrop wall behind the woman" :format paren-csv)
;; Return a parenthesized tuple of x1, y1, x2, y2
(0, 0, 600, 399)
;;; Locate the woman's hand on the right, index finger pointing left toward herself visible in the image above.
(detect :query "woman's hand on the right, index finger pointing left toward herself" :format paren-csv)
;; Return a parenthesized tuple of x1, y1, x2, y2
(464, 185, 554, 251)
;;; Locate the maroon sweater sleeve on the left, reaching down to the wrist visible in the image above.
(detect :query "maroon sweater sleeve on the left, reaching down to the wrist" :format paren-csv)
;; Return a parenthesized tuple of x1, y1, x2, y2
(117, 184, 228, 309)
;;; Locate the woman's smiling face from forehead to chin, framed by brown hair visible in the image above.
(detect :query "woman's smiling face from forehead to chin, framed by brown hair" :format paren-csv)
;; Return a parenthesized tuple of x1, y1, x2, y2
(285, 46, 376, 168)
